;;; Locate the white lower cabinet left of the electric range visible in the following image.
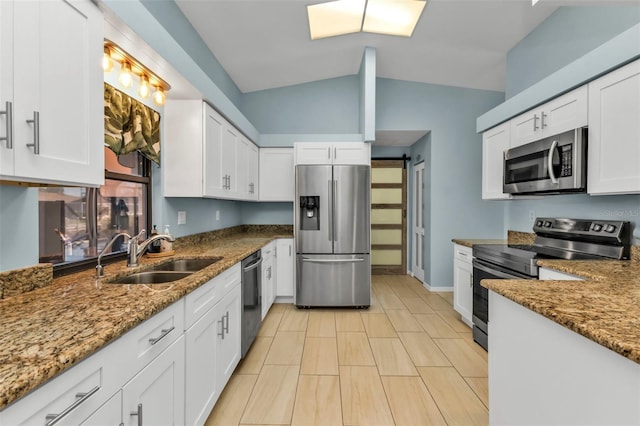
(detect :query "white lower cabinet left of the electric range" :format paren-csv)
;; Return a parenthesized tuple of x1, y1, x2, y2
(453, 244, 473, 327)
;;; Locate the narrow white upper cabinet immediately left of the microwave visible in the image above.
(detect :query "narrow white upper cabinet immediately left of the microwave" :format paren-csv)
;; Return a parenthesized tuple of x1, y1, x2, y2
(482, 122, 511, 200)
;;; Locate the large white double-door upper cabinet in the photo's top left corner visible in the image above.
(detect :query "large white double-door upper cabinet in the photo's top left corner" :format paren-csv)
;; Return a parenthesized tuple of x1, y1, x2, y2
(0, 0, 104, 186)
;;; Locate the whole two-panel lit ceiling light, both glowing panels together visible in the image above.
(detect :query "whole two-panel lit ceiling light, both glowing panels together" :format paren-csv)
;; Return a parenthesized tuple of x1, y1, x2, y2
(307, 0, 427, 40)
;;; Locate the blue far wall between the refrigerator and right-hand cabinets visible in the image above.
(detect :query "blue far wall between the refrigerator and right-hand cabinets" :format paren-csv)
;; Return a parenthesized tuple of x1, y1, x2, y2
(376, 78, 504, 287)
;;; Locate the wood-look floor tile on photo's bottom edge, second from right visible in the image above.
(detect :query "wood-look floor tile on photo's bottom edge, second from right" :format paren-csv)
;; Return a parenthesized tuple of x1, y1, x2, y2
(382, 376, 447, 426)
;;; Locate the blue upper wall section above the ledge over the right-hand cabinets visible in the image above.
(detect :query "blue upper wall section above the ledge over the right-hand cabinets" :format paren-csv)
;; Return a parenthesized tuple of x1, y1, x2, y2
(506, 6, 640, 98)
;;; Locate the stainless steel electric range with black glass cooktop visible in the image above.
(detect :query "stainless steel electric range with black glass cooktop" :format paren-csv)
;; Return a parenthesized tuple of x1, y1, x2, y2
(473, 218, 632, 350)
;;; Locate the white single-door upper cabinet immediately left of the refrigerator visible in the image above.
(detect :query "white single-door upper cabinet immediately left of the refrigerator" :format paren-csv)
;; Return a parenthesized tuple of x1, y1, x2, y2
(260, 148, 295, 201)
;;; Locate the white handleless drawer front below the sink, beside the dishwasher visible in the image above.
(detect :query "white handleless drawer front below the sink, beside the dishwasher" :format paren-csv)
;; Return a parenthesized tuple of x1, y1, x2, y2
(184, 263, 241, 330)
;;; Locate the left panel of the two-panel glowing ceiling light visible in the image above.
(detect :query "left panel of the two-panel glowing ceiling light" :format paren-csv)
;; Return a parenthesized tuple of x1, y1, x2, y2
(307, 0, 365, 40)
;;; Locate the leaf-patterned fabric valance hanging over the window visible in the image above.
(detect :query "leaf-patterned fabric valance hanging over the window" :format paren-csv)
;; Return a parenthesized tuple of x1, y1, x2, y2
(104, 83, 160, 165)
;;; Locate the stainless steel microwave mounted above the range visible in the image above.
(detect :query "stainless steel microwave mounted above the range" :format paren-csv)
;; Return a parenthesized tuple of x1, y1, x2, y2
(502, 127, 587, 194)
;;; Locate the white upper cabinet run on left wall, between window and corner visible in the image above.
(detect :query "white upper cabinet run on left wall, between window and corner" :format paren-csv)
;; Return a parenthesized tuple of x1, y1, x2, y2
(162, 100, 258, 200)
